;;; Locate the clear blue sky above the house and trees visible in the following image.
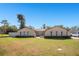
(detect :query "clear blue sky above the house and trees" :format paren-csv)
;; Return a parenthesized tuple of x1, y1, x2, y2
(0, 3, 79, 28)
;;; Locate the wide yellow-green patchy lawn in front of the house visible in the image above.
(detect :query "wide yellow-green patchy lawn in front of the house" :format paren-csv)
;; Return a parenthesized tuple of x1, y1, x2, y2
(0, 38, 79, 56)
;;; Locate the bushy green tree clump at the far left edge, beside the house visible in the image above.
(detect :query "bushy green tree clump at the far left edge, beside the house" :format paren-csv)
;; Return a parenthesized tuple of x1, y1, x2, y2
(0, 20, 17, 34)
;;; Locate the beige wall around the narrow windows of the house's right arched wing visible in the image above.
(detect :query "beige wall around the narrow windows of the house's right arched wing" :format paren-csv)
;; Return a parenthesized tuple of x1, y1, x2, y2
(45, 27, 70, 36)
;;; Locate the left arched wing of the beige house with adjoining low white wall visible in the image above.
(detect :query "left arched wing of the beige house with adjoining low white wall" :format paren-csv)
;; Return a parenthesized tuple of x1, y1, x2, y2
(9, 28, 36, 37)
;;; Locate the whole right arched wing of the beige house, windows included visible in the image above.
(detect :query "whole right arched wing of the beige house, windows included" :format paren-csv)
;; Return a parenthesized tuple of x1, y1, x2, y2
(44, 27, 70, 37)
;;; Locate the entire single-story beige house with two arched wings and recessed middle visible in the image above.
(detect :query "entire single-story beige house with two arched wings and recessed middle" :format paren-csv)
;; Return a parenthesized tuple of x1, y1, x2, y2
(9, 27, 70, 37)
